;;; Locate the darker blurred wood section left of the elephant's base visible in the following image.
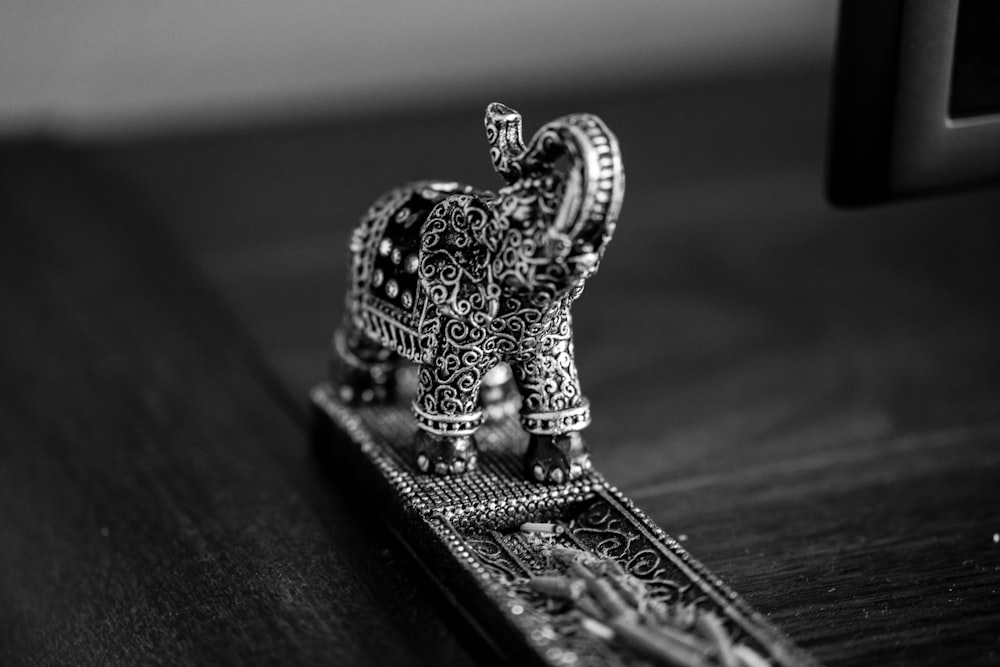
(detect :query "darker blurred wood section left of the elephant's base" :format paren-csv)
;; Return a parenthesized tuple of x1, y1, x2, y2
(0, 142, 486, 665)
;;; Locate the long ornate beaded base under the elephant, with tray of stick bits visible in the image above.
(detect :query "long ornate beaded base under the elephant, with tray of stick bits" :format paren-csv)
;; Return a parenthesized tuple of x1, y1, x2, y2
(311, 384, 815, 667)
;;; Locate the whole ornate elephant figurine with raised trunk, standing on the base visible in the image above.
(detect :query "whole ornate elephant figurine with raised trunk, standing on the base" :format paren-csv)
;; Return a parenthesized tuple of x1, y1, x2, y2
(332, 103, 625, 484)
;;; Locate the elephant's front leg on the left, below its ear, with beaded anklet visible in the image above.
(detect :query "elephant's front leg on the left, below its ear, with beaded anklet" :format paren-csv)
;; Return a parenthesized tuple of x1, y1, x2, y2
(413, 355, 496, 475)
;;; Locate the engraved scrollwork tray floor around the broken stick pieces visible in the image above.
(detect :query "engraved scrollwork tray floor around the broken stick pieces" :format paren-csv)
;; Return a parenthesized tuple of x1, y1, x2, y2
(450, 497, 800, 665)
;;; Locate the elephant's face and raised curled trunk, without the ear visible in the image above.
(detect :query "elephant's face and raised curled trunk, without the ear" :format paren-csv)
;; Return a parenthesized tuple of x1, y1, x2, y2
(485, 102, 625, 306)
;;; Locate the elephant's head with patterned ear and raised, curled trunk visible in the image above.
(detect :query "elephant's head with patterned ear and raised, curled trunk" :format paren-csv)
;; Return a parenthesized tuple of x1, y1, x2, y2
(420, 103, 625, 326)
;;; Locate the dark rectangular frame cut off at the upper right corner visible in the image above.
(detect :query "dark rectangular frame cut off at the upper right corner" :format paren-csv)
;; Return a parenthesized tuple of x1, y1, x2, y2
(827, 0, 1000, 206)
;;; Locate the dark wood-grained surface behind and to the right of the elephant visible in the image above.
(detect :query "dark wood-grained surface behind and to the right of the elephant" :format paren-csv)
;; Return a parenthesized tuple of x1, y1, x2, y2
(25, 71, 1000, 665)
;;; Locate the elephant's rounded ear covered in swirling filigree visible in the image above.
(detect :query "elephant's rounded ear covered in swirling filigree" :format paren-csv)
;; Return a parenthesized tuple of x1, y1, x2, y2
(420, 195, 500, 327)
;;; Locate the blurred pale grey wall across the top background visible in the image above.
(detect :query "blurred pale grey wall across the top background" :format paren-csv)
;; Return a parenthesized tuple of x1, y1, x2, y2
(0, 0, 836, 135)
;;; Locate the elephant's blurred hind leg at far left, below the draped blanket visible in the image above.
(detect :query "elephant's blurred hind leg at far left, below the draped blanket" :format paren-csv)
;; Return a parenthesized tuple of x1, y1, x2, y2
(330, 318, 402, 405)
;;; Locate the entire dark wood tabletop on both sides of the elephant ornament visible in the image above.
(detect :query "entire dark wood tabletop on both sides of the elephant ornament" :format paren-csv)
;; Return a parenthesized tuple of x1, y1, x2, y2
(0, 66, 1000, 665)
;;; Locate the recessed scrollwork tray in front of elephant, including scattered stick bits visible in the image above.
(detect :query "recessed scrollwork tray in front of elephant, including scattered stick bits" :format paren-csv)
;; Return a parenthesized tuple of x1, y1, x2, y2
(464, 498, 796, 667)
